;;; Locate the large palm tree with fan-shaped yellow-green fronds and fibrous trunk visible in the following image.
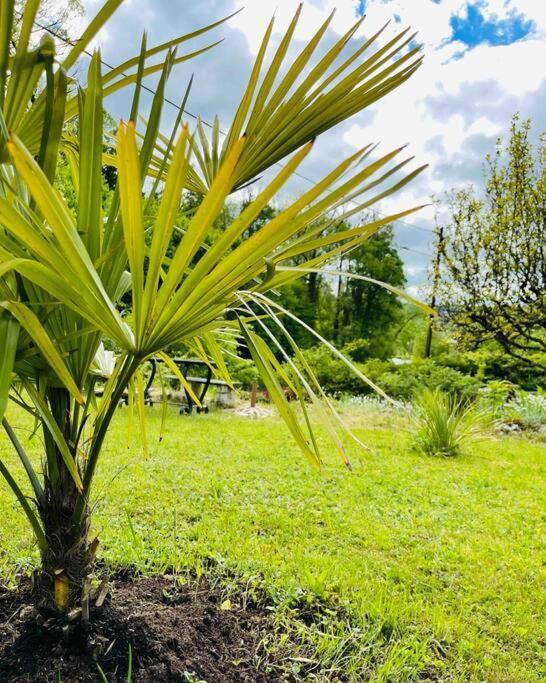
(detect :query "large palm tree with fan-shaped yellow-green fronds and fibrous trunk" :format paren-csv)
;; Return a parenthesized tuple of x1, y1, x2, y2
(0, 0, 428, 613)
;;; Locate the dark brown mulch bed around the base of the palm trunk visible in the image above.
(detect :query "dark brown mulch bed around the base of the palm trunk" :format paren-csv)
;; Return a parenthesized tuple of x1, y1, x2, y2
(0, 577, 278, 683)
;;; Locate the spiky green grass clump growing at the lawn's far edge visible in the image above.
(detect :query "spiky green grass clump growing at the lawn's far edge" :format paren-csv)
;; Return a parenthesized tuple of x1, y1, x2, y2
(413, 389, 486, 457)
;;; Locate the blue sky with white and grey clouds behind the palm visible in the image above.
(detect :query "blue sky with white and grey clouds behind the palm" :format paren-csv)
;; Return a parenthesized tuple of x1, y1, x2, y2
(71, 0, 546, 291)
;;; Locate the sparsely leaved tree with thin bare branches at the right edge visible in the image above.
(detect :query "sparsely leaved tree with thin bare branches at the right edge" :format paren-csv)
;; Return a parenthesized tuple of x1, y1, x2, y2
(440, 115, 546, 367)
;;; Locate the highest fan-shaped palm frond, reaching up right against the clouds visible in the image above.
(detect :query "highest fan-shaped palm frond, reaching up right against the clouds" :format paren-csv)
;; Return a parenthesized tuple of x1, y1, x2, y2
(153, 5, 422, 195)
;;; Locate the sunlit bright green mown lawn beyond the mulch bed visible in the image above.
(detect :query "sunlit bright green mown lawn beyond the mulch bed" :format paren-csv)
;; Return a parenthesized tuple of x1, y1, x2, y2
(0, 407, 546, 683)
